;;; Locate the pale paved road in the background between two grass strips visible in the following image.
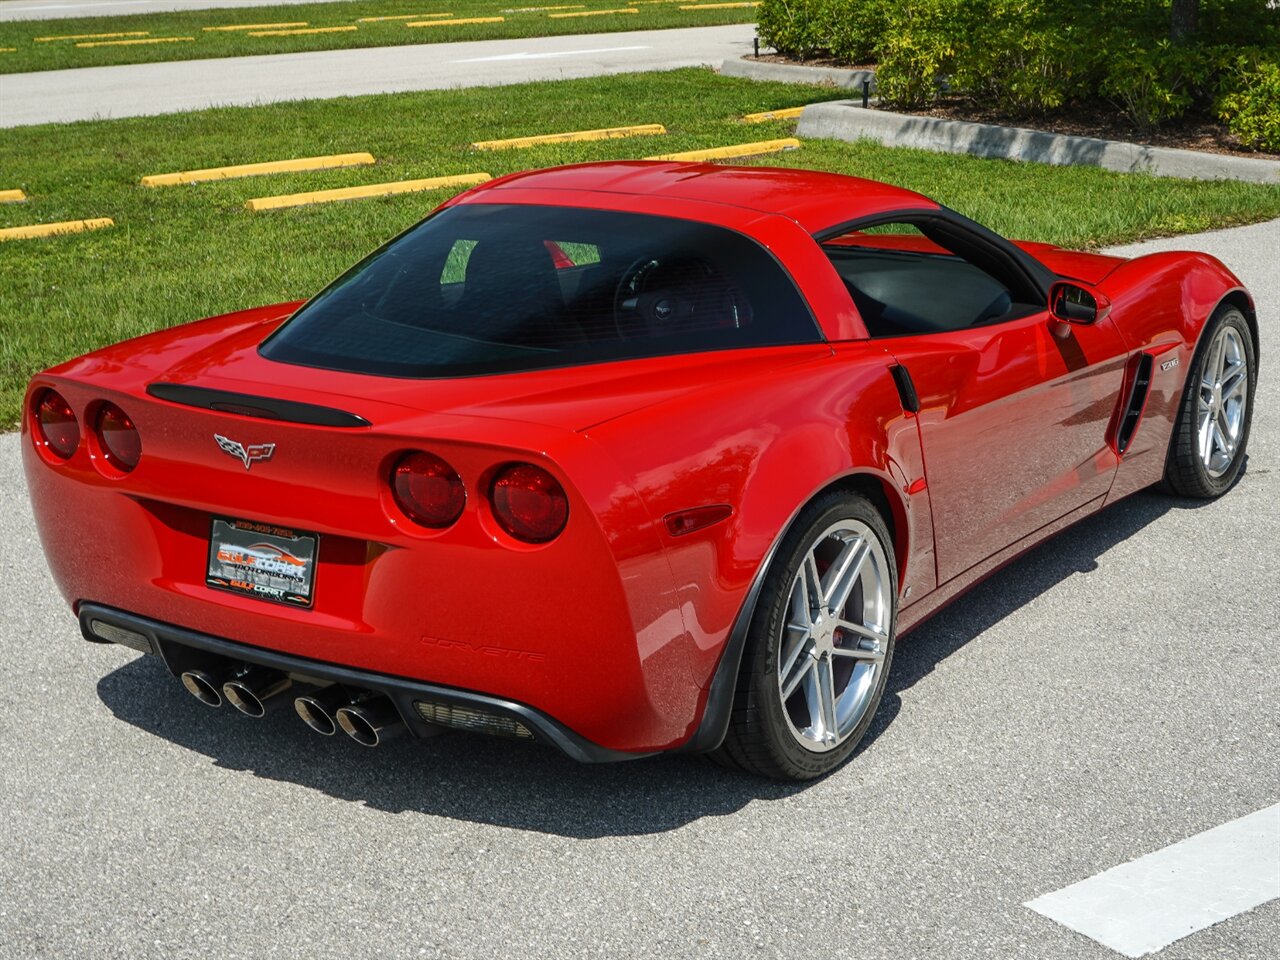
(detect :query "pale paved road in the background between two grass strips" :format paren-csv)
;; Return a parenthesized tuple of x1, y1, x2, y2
(0, 23, 755, 127)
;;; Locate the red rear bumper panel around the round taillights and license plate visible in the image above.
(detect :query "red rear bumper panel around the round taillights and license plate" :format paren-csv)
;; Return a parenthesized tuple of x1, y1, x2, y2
(22, 374, 707, 754)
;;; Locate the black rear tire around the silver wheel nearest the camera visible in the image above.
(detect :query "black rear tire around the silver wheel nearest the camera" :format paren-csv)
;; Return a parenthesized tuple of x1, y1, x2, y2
(713, 490, 897, 781)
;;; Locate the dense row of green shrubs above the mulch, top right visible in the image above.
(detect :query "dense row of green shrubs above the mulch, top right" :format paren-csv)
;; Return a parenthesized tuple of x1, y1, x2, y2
(760, 0, 1280, 128)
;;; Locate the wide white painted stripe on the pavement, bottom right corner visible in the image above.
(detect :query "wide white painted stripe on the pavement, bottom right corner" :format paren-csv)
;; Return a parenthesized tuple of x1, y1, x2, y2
(1024, 804, 1280, 956)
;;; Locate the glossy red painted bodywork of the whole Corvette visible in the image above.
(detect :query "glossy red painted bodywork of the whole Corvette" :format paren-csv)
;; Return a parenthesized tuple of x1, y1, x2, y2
(23, 163, 1240, 753)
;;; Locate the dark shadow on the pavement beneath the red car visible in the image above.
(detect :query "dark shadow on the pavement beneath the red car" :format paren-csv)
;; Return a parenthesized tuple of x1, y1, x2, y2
(97, 493, 1199, 837)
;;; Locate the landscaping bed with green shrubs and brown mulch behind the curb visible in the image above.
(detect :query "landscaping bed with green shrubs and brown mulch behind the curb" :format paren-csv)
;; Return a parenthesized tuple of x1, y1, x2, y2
(759, 0, 1280, 152)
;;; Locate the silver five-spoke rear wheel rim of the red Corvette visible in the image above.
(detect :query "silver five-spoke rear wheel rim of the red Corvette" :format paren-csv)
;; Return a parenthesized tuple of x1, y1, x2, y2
(778, 518, 893, 751)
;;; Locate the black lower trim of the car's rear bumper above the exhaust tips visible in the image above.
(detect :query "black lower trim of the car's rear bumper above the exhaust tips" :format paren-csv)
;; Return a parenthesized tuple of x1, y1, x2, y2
(79, 603, 648, 763)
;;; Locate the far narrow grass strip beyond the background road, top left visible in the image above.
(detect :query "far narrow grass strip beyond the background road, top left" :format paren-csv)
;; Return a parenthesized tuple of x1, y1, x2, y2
(0, 0, 755, 73)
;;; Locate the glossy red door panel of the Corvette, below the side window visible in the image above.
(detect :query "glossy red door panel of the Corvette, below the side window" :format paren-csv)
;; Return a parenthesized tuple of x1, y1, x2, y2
(882, 311, 1128, 582)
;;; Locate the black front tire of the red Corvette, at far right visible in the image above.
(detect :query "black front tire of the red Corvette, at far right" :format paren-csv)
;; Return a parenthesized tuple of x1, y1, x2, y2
(1164, 303, 1258, 499)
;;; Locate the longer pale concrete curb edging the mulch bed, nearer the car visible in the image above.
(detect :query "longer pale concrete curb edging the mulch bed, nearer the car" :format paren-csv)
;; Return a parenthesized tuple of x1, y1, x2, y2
(796, 100, 1280, 183)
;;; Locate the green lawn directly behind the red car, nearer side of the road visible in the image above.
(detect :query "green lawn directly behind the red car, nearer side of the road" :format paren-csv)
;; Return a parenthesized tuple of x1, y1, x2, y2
(0, 69, 1280, 425)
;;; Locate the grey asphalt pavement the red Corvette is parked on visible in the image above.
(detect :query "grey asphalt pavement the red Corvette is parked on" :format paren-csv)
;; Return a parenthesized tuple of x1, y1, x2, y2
(0, 220, 1280, 960)
